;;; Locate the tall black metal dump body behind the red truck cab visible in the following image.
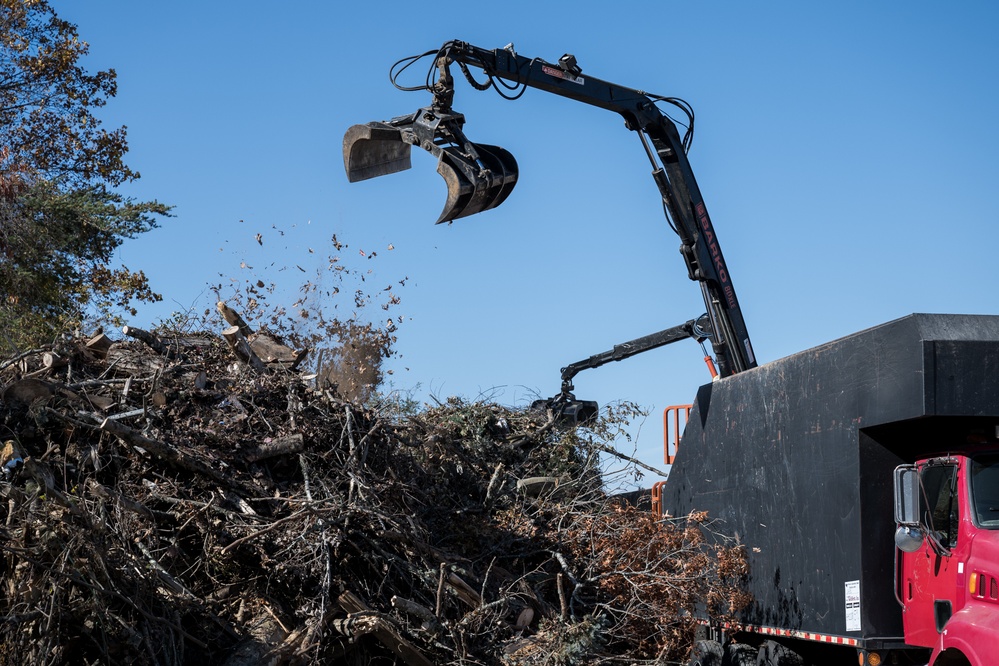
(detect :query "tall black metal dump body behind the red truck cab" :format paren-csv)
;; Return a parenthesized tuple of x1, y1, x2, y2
(663, 314, 999, 649)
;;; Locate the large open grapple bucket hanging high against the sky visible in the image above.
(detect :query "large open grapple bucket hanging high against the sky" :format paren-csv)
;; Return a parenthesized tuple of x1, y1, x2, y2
(343, 108, 517, 224)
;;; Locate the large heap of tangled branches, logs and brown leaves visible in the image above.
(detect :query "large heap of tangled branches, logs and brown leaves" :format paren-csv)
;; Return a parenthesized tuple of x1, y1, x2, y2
(0, 326, 746, 666)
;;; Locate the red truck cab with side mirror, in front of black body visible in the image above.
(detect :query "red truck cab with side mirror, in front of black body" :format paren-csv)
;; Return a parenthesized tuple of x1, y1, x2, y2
(895, 451, 999, 666)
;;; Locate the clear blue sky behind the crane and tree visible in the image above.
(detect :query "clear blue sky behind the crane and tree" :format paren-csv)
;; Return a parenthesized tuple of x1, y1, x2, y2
(53, 0, 999, 478)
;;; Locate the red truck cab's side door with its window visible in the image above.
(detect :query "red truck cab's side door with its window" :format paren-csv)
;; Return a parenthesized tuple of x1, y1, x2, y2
(900, 459, 960, 647)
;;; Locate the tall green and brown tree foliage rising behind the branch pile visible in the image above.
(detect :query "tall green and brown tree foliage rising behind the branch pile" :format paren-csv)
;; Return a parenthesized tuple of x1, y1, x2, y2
(0, 0, 169, 351)
